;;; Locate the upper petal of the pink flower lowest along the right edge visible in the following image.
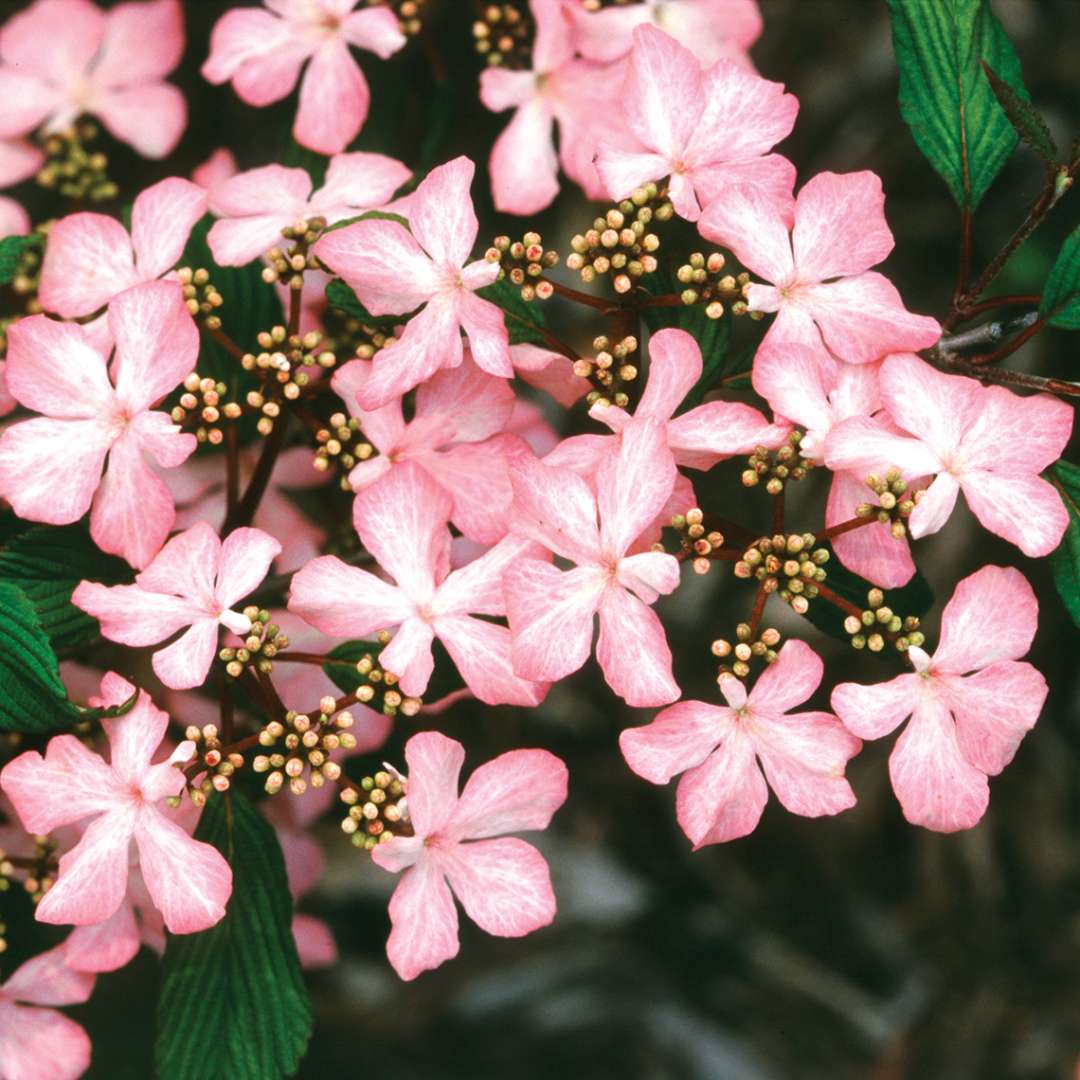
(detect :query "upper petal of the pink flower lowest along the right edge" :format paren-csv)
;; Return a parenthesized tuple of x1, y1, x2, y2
(933, 566, 1039, 675)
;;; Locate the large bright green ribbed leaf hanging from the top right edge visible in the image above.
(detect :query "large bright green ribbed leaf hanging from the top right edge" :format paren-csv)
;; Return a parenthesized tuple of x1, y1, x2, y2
(888, 0, 1030, 211)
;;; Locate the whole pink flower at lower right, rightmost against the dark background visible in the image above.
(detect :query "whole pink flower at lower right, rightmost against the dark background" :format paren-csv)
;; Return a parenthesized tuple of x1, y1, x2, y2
(833, 566, 1047, 833)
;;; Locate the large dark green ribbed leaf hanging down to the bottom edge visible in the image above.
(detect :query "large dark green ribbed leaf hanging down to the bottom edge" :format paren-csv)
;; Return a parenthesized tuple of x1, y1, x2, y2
(154, 789, 312, 1080)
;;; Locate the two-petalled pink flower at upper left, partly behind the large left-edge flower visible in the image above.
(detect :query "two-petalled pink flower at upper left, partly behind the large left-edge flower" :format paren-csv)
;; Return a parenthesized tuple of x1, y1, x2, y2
(40, 176, 206, 317)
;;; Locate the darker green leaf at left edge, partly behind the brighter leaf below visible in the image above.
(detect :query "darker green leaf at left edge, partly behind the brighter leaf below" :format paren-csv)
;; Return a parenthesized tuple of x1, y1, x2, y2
(0, 525, 133, 649)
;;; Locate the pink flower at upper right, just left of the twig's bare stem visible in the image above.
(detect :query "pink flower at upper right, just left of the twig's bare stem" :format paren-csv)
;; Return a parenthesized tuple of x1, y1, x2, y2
(699, 172, 941, 364)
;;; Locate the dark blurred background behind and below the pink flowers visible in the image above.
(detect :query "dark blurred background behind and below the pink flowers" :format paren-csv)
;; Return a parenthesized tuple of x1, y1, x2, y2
(0, 0, 1080, 1080)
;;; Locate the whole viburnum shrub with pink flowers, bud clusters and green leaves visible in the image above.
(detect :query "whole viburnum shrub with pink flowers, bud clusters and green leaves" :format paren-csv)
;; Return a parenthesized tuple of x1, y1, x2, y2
(0, 0, 1080, 1080)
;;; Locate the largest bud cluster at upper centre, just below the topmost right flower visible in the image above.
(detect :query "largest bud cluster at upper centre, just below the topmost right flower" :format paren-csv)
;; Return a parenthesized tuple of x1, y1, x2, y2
(566, 183, 675, 293)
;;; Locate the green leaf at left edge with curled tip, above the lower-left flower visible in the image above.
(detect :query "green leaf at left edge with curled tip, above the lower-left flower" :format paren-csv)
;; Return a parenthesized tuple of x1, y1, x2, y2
(0, 581, 135, 734)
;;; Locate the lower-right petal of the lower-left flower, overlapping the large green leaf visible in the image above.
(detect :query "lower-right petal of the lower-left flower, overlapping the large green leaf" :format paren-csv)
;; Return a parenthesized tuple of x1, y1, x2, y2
(135, 807, 232, 934)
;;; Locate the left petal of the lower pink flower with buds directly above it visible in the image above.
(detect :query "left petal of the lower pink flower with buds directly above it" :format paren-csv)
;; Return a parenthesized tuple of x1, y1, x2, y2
(619, 701, 733, 784)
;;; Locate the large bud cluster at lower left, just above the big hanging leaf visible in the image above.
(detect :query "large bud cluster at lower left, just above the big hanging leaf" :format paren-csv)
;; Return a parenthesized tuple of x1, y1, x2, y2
(252, 696, 356, 795)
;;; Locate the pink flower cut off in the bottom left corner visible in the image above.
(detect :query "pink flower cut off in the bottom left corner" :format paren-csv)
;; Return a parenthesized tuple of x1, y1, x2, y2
(0, 945, 94, 1080)
